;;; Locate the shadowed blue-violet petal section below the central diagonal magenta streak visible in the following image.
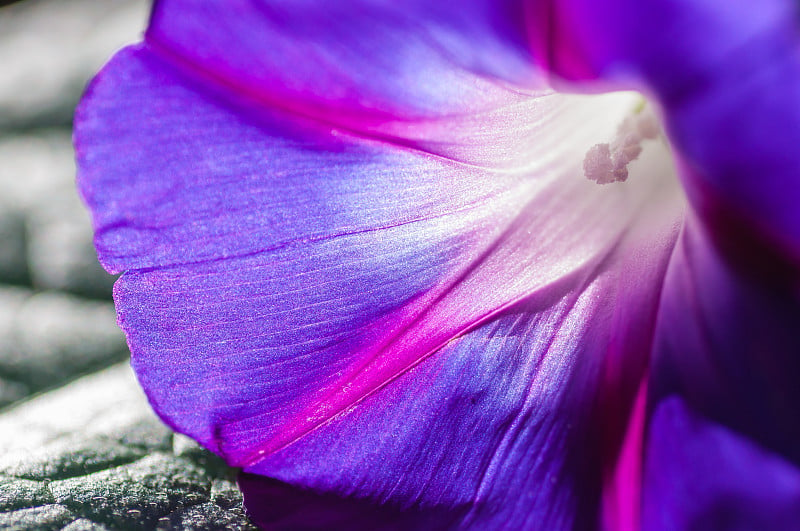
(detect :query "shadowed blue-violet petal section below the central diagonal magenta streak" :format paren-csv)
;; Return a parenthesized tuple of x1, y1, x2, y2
(242, 214, 674, 529)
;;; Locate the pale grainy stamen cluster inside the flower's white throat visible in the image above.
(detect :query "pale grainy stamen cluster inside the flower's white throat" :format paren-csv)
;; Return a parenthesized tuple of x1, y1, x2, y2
(583, 101, 662, 184)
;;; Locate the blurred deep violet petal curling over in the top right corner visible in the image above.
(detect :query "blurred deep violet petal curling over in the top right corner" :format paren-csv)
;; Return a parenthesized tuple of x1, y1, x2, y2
(531, 0, 800, 268)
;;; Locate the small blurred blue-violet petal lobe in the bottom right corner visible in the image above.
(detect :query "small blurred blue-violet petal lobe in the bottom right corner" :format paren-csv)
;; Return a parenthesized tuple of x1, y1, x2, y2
(642, 397, 800, 531)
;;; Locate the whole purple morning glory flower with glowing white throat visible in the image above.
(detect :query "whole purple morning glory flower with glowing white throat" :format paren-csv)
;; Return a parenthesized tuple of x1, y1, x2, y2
(75, 0, 800, 529)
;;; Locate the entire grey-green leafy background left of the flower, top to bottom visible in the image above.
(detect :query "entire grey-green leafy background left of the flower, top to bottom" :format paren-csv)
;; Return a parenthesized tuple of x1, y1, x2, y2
(0, 0, 251, 531)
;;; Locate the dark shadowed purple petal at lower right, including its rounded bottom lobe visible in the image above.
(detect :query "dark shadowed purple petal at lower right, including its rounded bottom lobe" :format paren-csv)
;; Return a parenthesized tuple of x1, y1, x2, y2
(644, 215, 800, 529)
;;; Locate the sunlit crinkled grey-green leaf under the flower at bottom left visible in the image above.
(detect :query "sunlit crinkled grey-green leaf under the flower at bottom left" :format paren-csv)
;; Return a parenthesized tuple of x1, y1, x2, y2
(0, 363, 251, 529)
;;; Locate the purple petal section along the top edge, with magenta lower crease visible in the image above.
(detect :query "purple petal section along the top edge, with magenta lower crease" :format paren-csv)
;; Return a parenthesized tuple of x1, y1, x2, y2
(146, 0, 542, 170)
